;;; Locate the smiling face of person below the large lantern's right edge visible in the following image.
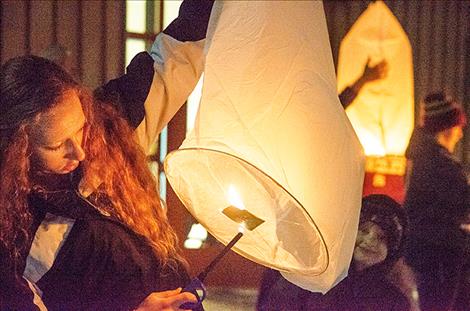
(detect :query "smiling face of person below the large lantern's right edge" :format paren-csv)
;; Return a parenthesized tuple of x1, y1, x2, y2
(353, 221, 388, 270)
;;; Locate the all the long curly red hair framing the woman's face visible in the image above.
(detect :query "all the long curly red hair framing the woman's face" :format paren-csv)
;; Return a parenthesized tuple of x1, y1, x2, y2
(0, 56, 184, 276)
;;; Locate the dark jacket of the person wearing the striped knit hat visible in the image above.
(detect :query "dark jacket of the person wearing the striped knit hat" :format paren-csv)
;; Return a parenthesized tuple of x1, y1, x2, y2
(404, 129, 470, 255)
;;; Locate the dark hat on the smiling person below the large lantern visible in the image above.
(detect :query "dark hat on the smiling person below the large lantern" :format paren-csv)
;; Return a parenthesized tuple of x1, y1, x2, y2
(360, 194, 408, 261)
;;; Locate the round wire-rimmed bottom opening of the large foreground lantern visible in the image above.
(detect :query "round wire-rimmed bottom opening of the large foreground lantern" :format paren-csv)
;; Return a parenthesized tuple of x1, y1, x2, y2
(164, 148, 329, 275)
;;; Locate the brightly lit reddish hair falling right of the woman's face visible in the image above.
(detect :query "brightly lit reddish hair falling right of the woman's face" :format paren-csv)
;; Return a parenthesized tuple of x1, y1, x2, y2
(81, 92, 182, 264)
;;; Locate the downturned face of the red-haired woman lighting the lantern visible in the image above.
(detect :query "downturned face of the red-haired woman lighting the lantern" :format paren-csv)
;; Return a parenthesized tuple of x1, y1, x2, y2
(31, 90, 86, 174)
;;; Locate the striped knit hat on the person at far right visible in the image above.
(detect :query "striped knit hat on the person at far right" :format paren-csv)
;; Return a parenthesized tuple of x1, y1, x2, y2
(422, 92, 467, 133)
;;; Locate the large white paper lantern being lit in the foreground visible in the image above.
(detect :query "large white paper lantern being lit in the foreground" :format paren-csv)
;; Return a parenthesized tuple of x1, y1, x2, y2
(165, 1, 364, 292)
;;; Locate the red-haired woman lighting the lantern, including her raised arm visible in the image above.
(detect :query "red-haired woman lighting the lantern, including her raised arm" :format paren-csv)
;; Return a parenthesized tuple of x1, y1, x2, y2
(0, 1, 212, 311)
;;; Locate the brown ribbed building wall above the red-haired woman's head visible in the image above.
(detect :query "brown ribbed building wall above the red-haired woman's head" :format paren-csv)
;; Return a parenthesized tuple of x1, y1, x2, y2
(0, 0, 125, 88)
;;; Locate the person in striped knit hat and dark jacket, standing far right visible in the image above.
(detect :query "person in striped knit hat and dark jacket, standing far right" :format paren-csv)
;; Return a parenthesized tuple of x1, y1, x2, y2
(404, 92, 470, 311)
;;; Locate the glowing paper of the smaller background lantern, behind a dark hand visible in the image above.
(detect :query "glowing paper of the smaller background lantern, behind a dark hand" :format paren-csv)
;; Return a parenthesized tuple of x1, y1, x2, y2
(338, 1, 414, 156)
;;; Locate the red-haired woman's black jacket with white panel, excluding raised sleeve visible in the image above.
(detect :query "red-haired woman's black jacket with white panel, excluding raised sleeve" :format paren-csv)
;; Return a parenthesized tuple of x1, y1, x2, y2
(17, 183, 193, 310)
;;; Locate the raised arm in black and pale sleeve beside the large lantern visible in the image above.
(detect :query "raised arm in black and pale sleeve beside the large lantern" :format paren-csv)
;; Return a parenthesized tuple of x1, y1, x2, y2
(95, 0, 213, 152)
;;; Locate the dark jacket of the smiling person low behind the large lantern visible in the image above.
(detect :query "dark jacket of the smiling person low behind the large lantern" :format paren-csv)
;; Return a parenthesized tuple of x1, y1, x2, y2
(257, 267, 409, 311)
